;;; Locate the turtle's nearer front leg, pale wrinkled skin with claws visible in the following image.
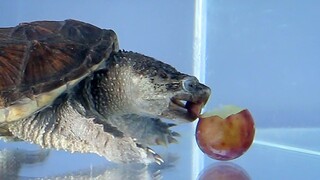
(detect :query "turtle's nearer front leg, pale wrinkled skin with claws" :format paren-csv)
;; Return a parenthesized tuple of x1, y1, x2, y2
(9, 101, 162, 164)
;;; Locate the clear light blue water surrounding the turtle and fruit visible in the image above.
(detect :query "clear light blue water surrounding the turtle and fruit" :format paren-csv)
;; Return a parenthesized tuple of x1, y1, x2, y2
(0, 0, 320, 180)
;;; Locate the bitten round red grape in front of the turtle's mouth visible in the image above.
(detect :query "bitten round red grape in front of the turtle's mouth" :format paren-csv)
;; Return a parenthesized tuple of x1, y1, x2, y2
(196, 106, 255, 160)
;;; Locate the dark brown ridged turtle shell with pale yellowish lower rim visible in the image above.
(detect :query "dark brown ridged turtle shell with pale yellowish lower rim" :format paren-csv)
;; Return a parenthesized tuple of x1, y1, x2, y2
(0, 20, 118, 123)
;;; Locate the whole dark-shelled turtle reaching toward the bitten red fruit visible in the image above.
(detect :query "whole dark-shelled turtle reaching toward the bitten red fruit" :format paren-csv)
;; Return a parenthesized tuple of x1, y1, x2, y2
(0, 20, 210, 163)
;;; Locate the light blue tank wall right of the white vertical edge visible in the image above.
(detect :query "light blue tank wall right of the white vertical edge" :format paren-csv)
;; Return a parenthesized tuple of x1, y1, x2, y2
(203, 1, 320, 179)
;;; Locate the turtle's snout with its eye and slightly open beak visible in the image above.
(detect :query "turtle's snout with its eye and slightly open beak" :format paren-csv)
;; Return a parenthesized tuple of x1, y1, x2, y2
(164, 77, 211, 122)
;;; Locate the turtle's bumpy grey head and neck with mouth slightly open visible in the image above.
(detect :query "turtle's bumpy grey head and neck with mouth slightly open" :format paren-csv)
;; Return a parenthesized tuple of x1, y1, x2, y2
(94, 51, 211, 121)
